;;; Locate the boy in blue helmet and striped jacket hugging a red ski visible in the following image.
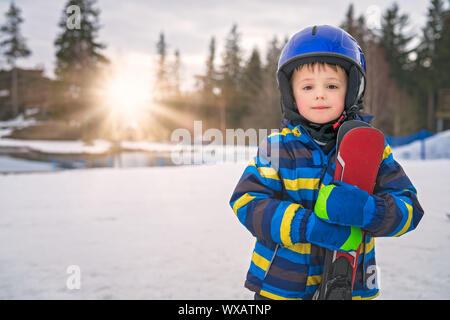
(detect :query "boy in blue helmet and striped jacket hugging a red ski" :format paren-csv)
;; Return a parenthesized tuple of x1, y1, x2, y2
(230, 25, 423, 299)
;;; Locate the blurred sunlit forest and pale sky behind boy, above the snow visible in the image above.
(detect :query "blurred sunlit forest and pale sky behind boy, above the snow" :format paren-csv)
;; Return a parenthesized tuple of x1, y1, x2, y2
(0, 0, 450, 141)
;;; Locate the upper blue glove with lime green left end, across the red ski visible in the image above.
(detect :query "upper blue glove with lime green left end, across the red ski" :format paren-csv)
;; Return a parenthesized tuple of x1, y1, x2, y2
(314, 181, 377, 231)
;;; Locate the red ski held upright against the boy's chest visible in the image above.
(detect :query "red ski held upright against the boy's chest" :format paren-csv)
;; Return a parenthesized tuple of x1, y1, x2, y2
(314, 120, 385, 300)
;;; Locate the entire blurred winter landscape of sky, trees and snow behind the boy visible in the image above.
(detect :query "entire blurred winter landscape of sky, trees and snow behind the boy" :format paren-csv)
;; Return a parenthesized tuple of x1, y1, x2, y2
(0, 0, 450, 299)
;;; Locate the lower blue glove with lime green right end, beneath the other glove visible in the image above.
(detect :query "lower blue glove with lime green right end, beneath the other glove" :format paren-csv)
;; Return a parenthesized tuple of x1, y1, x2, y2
(305, 212, 362, 251)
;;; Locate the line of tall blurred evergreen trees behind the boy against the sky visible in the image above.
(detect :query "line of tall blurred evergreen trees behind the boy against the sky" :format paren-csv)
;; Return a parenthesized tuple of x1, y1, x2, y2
(0, 0, 450, 138)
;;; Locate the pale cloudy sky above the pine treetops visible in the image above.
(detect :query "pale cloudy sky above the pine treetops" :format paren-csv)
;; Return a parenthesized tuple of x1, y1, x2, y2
(0, 0, 436, 90)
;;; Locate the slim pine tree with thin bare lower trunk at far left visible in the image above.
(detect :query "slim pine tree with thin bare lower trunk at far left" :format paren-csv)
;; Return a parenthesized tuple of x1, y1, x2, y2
(0, 1, 31, 117)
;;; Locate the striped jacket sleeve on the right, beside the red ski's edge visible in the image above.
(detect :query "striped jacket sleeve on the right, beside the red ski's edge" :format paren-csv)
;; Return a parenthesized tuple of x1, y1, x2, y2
(369, 144, 424, 237)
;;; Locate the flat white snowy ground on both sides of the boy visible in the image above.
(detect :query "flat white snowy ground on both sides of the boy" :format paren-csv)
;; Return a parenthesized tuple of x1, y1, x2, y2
(0, 160, 450, 299)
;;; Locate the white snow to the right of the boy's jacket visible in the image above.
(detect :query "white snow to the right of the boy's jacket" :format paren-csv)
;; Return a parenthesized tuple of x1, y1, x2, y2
(375, 159, 450, 299)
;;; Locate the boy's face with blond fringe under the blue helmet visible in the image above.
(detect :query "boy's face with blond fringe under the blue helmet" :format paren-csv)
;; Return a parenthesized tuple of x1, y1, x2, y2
(292, 63, 347, 124)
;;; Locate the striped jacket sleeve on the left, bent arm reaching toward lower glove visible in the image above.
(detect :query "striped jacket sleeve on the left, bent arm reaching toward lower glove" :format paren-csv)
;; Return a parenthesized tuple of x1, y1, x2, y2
(230, 136, 311, 246)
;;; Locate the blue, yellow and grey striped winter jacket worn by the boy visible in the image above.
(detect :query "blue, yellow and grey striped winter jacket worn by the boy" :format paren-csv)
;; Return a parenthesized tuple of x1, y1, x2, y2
(230, 114, 423, 299)
